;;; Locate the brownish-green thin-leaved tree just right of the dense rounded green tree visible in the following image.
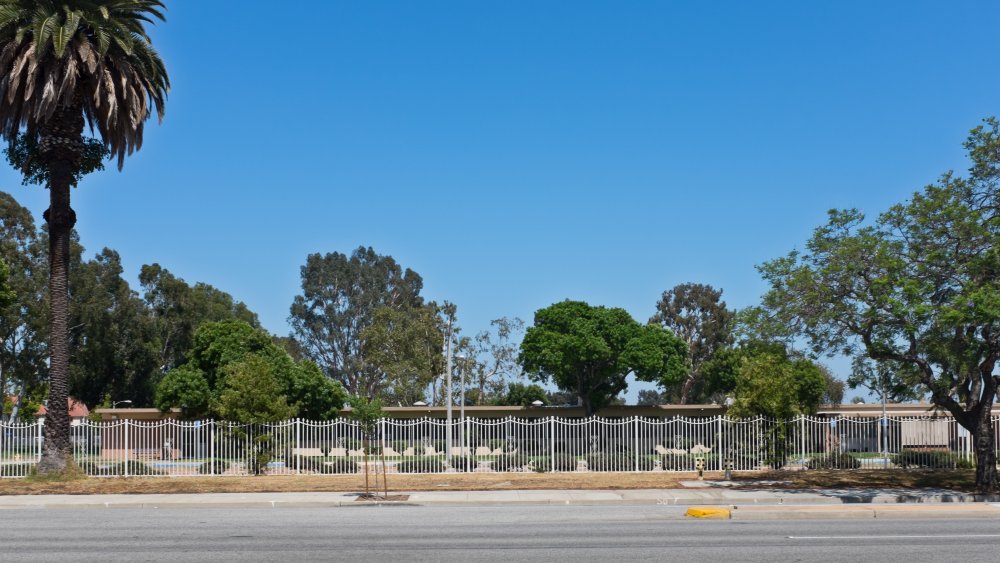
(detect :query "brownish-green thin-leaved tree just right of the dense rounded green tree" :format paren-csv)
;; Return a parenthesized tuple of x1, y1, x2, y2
(649, 283, 734, 405)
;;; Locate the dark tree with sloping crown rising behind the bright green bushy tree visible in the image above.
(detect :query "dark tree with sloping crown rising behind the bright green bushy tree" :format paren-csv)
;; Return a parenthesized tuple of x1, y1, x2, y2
(139, 264, 260, 370)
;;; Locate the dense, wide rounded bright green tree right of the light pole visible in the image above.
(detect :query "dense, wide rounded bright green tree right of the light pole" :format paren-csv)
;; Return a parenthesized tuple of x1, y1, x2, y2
(519, 300, 683, 416)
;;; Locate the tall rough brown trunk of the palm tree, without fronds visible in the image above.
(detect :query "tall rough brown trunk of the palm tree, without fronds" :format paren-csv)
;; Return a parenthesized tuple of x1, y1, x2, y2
(37, 106, 83, 475)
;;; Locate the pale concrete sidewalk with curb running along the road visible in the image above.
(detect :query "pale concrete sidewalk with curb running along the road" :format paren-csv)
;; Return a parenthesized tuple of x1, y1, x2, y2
(0, 487, 1000, 519)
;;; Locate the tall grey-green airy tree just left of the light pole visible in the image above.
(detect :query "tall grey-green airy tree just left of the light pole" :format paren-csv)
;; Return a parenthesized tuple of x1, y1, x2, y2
(289, 247, 442, 398)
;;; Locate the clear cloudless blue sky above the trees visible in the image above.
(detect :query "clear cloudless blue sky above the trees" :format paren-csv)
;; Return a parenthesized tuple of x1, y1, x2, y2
(0, 0, 1000, 404)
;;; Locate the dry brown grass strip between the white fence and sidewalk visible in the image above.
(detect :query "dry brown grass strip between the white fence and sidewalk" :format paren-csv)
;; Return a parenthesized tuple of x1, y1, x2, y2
(0, 469, 975, 495)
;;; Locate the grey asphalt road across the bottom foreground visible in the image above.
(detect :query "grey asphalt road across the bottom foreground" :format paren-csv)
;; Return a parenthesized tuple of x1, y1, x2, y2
(0, 505, 1000, 563)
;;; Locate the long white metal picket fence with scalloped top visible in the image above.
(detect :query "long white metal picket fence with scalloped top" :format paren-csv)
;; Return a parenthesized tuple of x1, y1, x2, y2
(0, 416, 1000, 477)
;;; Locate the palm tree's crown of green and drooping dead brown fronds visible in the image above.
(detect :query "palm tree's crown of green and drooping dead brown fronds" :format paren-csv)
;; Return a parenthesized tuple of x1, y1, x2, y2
(0, 0, 170, 167)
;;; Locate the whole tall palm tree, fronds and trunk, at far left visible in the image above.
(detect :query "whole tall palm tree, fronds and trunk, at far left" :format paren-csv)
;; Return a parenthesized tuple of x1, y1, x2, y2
(0, 0, 170, 474)
